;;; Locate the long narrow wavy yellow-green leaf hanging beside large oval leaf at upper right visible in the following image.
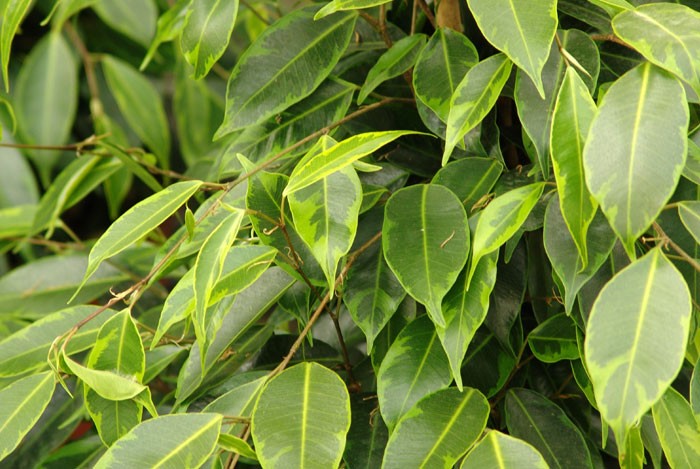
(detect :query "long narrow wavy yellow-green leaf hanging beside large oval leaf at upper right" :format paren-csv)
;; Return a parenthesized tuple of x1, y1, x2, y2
(550, 67, 598, 268)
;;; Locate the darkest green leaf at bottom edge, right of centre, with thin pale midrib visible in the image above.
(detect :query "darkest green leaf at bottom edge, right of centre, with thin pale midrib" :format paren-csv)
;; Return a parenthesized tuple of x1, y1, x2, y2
(505, 388, 593, 469)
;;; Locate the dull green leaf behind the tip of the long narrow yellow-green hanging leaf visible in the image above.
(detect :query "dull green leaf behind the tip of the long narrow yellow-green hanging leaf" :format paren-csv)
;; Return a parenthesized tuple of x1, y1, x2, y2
(544, 196, 615, 314)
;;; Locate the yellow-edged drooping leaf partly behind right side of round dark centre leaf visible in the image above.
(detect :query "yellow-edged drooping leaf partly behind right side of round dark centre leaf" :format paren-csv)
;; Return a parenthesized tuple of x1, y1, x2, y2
(436, 252, 498, 389)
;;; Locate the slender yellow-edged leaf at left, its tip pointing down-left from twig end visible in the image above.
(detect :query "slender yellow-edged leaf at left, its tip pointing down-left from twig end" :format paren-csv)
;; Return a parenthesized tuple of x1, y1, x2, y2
(81, 181, 202, 294)
